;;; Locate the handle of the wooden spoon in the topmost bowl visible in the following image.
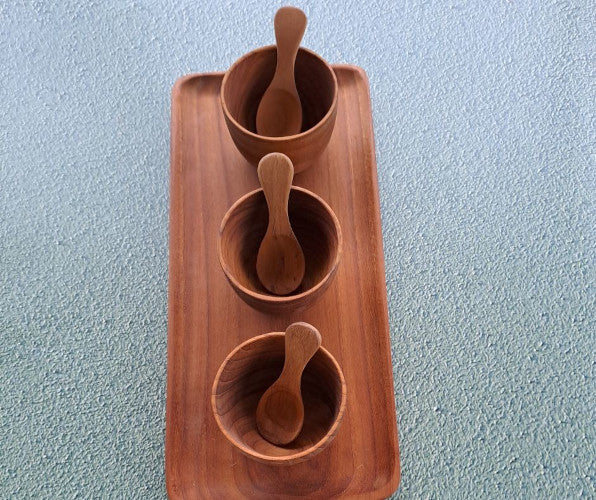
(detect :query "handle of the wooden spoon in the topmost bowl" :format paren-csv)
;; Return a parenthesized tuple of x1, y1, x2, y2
(274, 7, 306, 79)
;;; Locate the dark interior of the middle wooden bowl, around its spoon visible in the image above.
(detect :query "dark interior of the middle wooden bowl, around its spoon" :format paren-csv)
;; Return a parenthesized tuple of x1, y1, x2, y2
(220, 188, 340, 297)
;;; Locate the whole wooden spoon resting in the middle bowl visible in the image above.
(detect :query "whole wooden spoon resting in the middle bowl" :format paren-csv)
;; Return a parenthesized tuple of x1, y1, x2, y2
(257, 153, 305, 295)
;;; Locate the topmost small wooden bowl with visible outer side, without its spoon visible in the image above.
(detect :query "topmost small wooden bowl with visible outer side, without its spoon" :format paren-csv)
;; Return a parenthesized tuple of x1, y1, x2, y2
(220, 45, 337, 173)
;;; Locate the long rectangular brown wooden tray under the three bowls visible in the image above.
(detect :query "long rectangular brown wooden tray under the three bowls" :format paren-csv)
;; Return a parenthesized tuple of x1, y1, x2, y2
(166, 65, 400, 499)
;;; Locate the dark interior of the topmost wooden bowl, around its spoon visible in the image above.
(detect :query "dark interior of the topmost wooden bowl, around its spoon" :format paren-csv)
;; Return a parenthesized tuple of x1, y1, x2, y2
(223, 46, 336, 134)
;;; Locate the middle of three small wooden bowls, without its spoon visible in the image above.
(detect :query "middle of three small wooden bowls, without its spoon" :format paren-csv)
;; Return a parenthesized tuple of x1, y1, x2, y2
(217, 186, 342, 313)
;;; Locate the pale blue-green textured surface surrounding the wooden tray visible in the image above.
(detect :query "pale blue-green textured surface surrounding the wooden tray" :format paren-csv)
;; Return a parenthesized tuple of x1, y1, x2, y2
(0, 0, 596, 499)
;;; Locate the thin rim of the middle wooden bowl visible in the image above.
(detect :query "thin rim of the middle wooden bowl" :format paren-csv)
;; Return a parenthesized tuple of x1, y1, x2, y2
(217, 186, 343, 305)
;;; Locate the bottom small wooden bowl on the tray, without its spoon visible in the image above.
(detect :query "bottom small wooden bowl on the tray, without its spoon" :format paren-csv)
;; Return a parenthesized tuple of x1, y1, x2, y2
(211, 332, 346, 465)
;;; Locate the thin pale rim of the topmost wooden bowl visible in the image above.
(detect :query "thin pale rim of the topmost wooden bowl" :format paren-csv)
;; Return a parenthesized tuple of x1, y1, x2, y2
(219, 45, 338, 143)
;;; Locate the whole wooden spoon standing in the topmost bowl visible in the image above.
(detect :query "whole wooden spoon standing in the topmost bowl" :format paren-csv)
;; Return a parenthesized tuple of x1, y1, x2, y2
(257, 7, 306, 137)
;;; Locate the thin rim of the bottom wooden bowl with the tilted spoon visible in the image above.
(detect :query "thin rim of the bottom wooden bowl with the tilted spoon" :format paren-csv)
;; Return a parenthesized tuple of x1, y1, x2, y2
(211, 332, 347, 465)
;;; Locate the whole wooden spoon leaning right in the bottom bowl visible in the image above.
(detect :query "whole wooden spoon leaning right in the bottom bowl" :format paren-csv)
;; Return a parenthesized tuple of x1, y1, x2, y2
(257, 323, 321, 445)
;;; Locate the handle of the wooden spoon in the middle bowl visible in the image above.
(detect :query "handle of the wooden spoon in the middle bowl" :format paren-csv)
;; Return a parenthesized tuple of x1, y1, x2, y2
(257, 153, 294, 231)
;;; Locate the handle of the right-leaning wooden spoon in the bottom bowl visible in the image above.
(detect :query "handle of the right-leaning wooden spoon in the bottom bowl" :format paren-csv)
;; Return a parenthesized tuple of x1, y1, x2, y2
(280, 322, 321, 380)
